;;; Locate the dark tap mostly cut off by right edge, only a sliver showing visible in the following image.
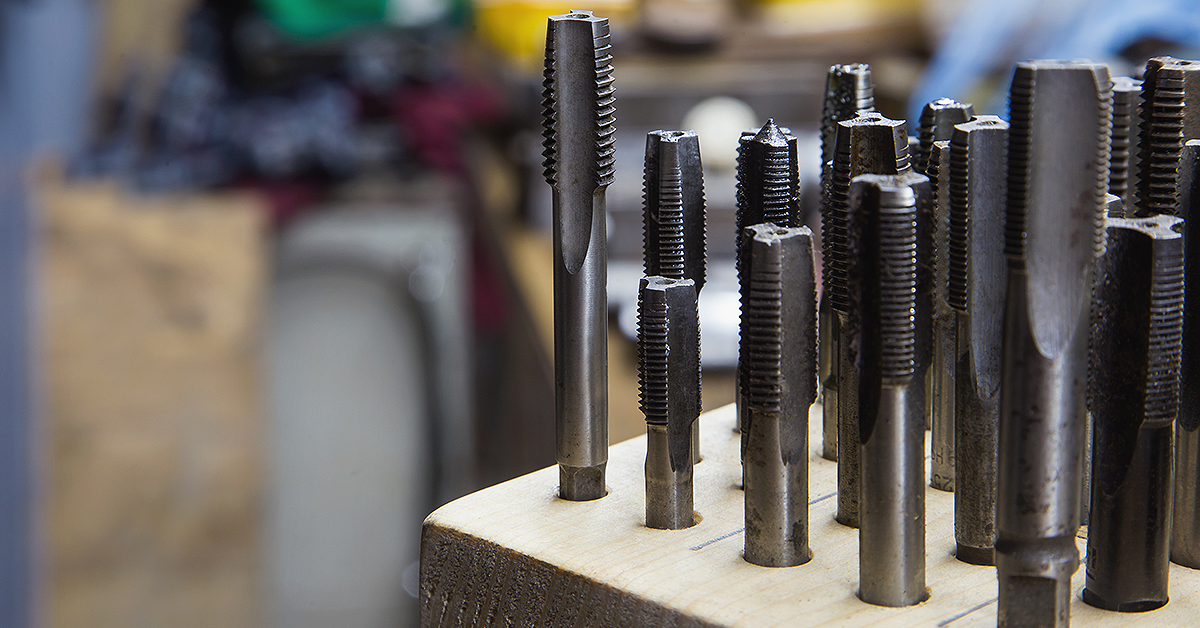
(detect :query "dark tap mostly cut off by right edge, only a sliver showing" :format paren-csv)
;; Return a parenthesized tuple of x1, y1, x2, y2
(1171, 139, 1200, 569)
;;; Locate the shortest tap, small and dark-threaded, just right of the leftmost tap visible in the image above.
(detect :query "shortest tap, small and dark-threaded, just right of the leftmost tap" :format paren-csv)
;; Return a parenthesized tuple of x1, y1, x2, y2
(637, 276, 700, 530)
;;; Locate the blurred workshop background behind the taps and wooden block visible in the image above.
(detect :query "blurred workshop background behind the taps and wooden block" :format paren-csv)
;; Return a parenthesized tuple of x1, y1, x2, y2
(0, 0, 1200, 628)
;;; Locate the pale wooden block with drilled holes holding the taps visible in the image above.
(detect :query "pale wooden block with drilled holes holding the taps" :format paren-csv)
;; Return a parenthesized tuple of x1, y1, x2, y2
(421, 406, 1200, 628)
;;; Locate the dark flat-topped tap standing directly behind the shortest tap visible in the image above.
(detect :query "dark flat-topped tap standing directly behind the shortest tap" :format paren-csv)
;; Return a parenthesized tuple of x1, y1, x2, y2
(642, 131, 704, 462)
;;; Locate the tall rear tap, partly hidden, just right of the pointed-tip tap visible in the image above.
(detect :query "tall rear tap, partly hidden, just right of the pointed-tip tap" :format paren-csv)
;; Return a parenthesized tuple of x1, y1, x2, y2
(818, 64, 875, 461)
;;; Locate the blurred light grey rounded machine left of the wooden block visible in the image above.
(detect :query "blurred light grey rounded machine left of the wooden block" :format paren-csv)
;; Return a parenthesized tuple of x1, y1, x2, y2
(265, 199, 474, 628)
